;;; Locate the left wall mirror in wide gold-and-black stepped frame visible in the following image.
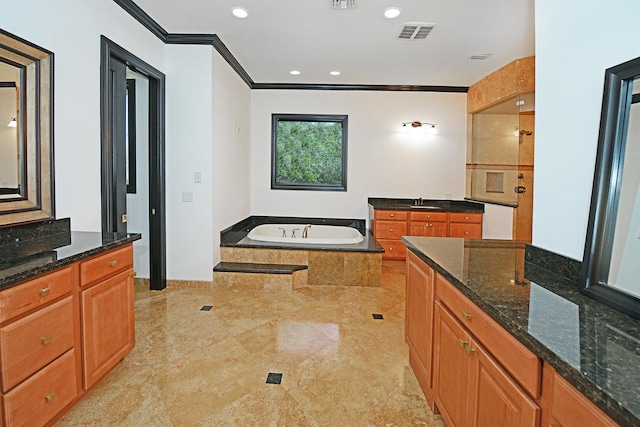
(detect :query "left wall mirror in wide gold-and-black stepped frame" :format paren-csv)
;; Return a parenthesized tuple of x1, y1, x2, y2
(0, 30, 55, 227)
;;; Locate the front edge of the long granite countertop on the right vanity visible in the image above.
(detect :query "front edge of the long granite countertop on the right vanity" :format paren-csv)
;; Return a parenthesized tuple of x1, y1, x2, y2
(402, 237, 640, 425)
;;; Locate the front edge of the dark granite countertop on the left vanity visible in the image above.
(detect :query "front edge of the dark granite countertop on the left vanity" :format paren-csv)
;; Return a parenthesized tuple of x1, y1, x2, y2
(0, 233, 141, 291)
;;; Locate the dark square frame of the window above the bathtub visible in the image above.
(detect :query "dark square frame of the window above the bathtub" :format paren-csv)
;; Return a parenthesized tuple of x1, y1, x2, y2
(271, 114, 349, 191)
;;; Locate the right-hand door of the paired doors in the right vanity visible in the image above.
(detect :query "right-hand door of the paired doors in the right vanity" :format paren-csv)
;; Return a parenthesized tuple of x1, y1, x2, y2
(467, 340, 540, 427)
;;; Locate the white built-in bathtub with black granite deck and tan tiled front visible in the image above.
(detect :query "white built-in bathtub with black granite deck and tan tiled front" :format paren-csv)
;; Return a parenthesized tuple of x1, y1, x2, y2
(214, 216, 384, 286)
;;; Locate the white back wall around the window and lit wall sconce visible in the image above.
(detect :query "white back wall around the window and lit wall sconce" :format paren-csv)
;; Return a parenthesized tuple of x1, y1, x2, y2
(251, 90, 467, 224)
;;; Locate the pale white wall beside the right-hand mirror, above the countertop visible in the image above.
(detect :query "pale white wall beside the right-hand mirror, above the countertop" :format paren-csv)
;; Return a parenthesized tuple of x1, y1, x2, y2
(533, 0, 640, 260)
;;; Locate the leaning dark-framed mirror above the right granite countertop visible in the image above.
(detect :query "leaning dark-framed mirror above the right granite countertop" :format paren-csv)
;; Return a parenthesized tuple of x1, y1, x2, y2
(580, 58, 640, 319)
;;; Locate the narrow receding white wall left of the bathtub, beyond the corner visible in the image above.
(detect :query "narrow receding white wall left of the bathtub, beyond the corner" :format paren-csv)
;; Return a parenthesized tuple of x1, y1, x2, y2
(210, 49, 251, 264)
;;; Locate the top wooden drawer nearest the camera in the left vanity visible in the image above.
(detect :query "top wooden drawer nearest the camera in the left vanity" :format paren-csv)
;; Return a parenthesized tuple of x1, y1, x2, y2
(0, 267, 73, 323)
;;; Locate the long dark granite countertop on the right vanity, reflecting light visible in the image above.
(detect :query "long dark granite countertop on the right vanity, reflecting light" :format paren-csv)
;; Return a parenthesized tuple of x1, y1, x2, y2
(402, 237, 640, 426)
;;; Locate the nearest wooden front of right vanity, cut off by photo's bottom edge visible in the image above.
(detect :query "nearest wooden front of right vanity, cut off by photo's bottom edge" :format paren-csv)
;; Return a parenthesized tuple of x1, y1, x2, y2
(542, 364, 618, 427)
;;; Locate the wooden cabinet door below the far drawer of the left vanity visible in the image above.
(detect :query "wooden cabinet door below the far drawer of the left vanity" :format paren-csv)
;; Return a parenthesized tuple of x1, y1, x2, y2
(82, 270, 135, 390)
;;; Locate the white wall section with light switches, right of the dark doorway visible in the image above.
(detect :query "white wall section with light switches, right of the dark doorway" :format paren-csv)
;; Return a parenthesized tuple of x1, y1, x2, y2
(166, 45, 214, 280)
